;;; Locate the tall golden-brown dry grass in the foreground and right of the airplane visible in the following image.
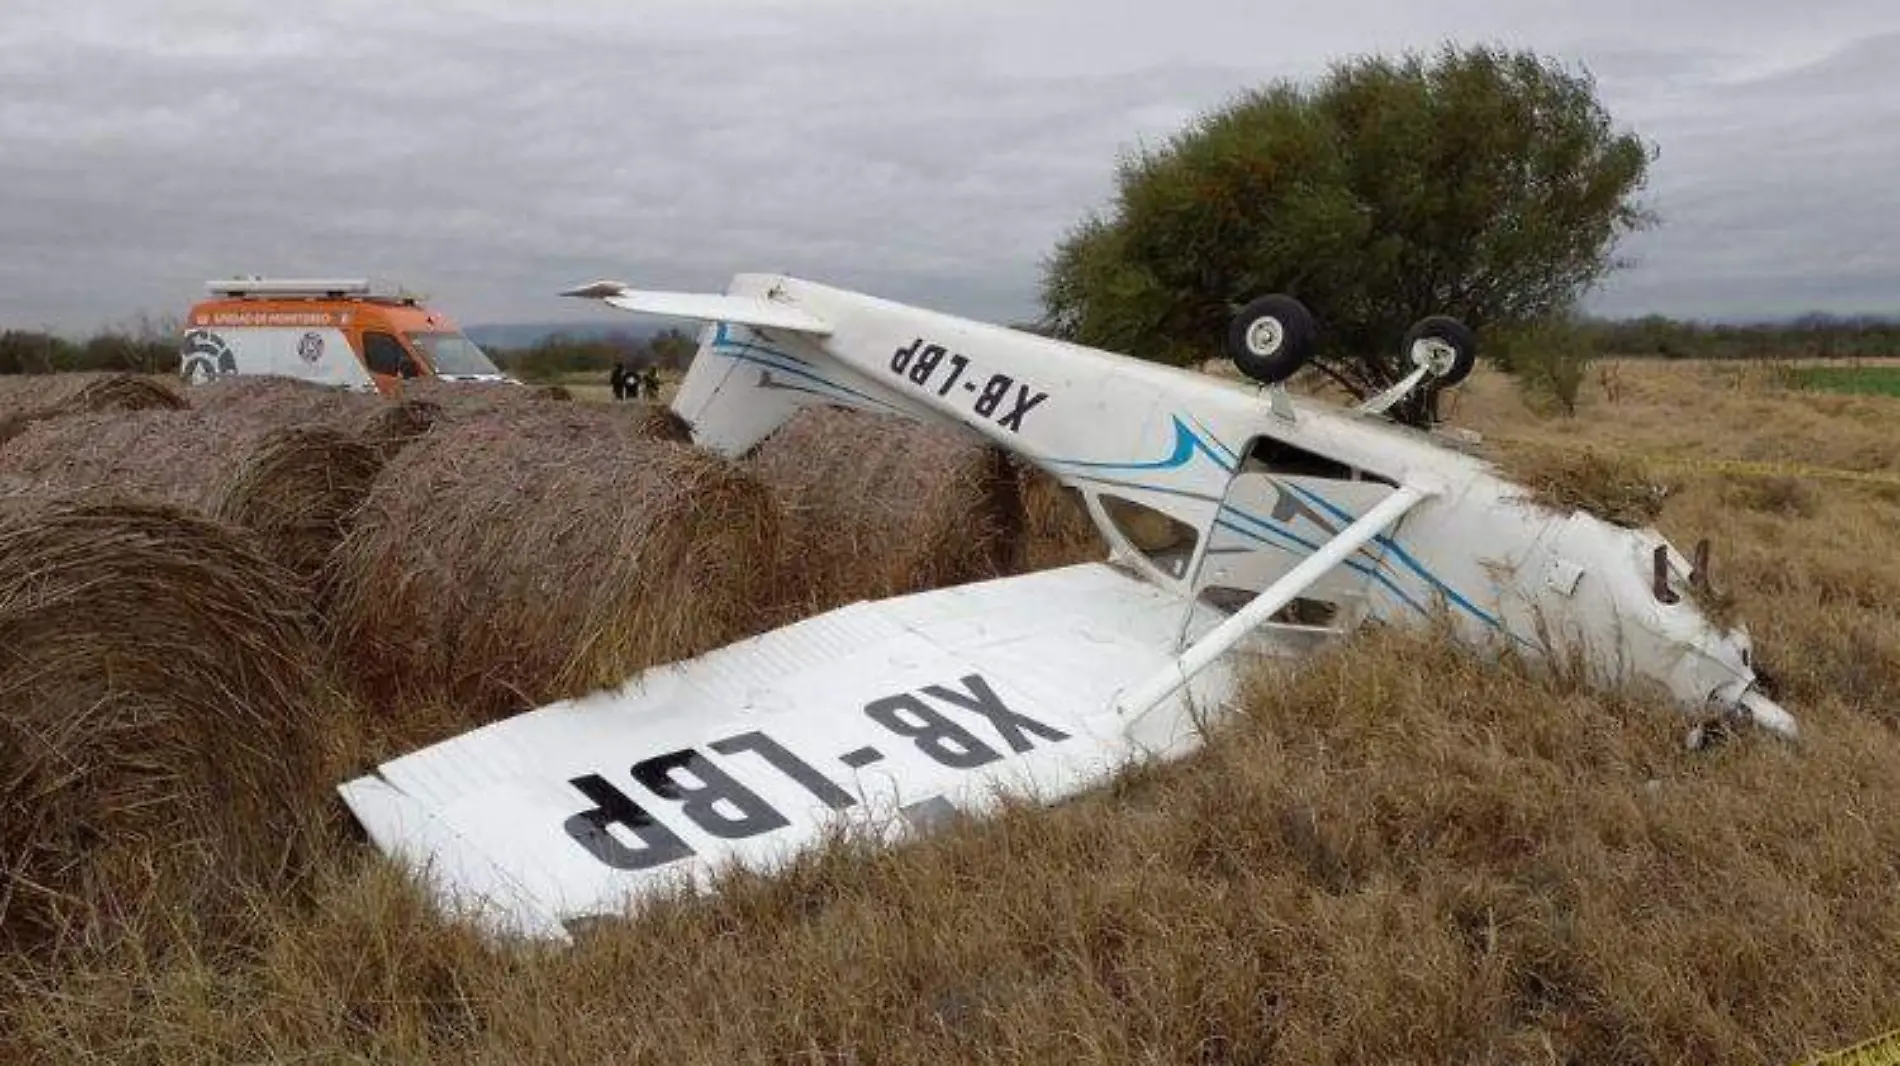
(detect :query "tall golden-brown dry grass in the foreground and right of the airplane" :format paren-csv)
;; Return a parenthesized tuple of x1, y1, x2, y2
(0, 367, 1900, 1064)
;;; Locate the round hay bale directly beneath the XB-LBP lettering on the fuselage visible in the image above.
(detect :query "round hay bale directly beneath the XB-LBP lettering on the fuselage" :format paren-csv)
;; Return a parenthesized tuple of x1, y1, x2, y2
(747, 407, 1022, 616)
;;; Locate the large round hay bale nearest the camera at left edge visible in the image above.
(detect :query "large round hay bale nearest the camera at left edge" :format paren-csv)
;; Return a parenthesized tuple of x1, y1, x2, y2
(0, 490, 329, 952)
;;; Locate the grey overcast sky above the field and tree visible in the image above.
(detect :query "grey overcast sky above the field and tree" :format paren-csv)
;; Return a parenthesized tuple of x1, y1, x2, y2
(0, 0, 1900, 331)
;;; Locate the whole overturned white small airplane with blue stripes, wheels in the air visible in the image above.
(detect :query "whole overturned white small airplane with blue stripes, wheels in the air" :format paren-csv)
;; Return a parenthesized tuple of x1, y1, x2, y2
(340, 274, 1796, 939)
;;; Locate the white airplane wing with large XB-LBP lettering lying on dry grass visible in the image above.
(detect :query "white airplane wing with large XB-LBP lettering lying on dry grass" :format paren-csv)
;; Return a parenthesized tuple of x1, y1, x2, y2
(338, 562, 1277, 941)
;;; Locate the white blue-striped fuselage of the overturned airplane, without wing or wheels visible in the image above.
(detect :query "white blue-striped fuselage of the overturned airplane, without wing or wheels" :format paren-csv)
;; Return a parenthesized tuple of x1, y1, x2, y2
(675, 274, 1759, 725)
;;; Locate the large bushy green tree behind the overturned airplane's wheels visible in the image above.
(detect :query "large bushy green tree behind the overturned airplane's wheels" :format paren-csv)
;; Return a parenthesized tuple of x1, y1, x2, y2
(1043, 46, 1653, 420)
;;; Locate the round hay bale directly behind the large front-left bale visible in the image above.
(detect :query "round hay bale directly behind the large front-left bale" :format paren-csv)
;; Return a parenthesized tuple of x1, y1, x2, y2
(0, 410, 386, 583)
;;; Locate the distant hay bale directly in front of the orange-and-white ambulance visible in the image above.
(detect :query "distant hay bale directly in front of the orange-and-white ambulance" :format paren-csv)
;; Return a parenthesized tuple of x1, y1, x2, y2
(184, 374, 441, 456)
